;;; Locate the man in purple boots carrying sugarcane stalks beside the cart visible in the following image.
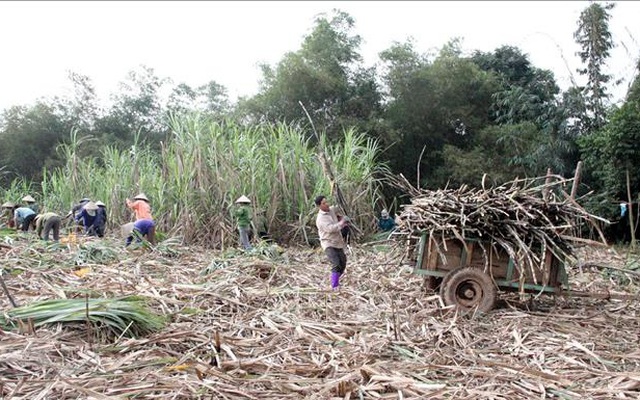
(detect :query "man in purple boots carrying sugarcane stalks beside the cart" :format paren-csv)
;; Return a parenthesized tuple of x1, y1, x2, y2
(315, 195, 349, 290)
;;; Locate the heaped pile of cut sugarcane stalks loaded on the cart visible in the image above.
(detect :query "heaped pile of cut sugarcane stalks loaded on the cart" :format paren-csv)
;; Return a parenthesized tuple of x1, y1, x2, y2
(390, 175, 609, 267)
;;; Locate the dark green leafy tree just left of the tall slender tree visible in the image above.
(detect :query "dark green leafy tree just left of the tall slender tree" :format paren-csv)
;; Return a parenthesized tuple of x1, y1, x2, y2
(471, 46, 582, 176)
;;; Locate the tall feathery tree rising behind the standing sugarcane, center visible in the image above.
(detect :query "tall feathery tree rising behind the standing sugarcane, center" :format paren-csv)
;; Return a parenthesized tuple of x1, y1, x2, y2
(238, 10, 380, 138)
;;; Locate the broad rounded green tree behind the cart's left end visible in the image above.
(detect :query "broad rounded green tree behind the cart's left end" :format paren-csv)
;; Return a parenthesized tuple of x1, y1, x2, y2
(380, 41, 498, 187)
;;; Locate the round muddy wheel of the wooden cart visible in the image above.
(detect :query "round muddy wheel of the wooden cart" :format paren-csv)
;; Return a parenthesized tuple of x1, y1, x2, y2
(440, 267, 497, 312)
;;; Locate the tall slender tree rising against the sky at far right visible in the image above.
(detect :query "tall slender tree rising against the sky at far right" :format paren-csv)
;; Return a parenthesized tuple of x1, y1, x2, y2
(573, 2, 615, 133)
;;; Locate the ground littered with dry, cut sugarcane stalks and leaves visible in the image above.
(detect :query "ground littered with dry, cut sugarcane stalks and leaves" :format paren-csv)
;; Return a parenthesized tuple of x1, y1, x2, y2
(0, 236, 640, 400)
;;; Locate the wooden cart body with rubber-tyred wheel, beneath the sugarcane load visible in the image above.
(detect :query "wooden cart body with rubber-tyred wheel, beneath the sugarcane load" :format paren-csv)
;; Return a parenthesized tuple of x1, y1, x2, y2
(410, 233, 568, 312)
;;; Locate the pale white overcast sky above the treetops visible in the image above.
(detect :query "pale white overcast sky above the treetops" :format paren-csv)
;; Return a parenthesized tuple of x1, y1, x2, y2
(0, 1, 640, 109)
